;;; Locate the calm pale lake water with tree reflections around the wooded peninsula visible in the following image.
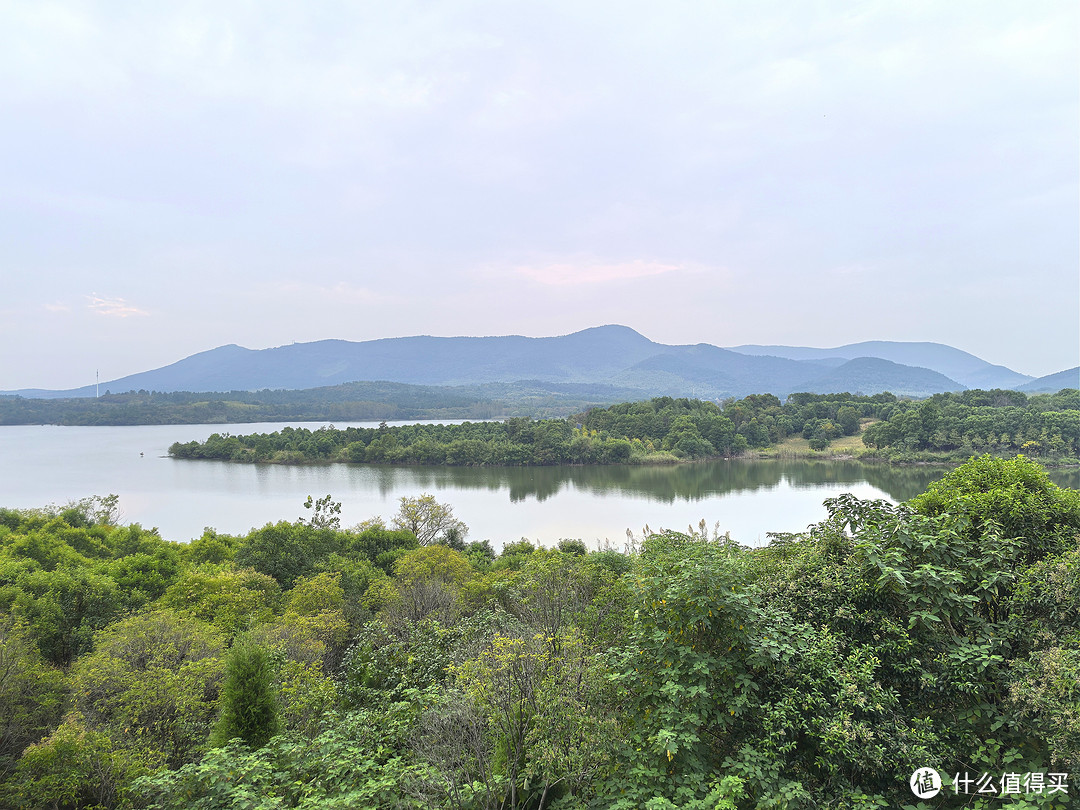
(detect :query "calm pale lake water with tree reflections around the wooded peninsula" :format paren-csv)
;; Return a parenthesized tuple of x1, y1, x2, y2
(0, 422, 1080, 548)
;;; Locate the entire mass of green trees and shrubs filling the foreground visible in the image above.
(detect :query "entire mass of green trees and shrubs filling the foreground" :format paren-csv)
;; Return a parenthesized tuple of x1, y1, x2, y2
(0, 460, 1080, 810)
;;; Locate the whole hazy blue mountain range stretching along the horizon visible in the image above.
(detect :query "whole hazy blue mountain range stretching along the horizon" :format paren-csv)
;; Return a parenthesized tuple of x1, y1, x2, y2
(6, 325, 1080, 399)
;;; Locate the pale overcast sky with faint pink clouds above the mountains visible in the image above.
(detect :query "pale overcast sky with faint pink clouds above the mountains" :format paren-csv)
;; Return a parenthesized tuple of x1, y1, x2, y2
(0, 0, 1080, 390)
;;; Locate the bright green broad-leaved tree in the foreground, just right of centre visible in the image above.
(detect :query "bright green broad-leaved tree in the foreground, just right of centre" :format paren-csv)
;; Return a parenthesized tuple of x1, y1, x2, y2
(610, 532, 780, 808)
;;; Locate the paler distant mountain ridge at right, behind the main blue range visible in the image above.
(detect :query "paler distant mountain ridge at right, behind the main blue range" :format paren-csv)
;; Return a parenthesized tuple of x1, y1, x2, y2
(732, 340, 1034, 393)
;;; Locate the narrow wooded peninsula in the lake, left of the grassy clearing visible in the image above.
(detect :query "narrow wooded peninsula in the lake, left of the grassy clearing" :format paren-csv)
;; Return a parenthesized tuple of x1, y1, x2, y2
(168, 394, 896, 467)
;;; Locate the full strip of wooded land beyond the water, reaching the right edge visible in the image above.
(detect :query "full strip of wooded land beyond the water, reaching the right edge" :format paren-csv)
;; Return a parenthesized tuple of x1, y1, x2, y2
(170, 390, 1080, 467)
